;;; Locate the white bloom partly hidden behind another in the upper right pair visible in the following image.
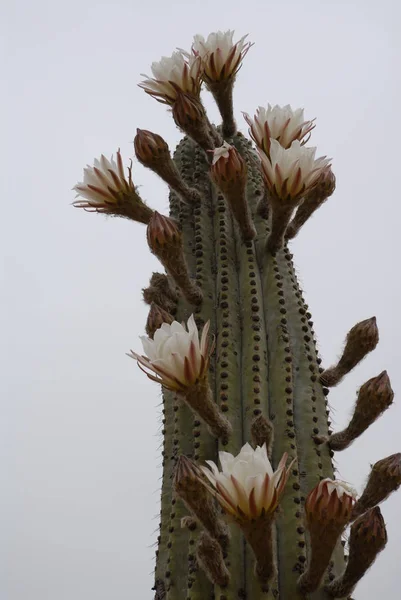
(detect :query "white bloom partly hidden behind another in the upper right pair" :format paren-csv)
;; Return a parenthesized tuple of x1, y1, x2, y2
(243, 104, 315, 154)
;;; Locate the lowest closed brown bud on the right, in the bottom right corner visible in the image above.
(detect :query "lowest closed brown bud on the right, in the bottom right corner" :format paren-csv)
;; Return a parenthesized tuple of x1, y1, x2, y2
(326, 506, 387, 598)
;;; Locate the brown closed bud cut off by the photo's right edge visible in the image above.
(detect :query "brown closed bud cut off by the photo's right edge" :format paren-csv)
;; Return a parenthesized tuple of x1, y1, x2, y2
(352, 453, 401, 519)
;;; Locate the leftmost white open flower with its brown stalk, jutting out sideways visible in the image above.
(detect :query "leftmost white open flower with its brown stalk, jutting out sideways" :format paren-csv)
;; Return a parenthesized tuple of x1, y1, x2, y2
(73, 151, 153, 224)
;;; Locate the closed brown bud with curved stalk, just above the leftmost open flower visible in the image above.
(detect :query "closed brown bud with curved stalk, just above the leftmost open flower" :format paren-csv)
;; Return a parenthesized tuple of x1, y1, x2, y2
(134, 129, 202, 204)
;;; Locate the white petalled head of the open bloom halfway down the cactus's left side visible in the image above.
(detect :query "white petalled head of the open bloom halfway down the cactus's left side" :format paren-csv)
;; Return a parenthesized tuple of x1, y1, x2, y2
(128, 315, 211, 392)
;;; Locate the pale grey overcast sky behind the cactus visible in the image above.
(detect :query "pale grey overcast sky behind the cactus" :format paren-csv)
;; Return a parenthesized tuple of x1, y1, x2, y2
(0, 0, 401, 600)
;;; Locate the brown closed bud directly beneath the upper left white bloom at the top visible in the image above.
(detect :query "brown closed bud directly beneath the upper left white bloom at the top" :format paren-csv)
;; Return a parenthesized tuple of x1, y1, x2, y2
(173, 93, 214, 151)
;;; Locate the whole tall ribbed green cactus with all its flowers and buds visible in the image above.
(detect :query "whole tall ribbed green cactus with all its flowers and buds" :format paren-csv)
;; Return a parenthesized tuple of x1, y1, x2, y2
(74, 31, 401, 600)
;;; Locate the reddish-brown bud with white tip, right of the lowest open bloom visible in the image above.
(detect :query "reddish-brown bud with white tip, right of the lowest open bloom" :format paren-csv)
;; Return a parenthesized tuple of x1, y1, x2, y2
(298, 479, 356, 594)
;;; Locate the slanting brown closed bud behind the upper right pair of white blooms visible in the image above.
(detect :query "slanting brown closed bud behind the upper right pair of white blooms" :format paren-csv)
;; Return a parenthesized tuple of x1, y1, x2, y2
(285, 167, 336, 240)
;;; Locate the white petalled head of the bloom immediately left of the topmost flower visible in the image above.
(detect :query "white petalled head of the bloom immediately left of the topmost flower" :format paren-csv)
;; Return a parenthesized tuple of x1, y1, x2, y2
(139, 50, 202, 105)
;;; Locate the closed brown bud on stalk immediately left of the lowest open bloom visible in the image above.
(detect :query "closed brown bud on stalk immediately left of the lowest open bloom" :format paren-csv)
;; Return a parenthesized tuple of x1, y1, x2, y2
(174, 455, 229, 547)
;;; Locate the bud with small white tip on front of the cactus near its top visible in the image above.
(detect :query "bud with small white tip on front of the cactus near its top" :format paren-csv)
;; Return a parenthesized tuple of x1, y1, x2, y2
(210, 142, 256, 241)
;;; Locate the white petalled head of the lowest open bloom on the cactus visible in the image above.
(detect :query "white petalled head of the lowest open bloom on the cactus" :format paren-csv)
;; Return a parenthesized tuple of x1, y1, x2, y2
(202, 444, 292, 520)
